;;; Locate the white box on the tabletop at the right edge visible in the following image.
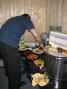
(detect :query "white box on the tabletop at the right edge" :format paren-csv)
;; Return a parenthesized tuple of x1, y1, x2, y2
(49, 31, 67, 50)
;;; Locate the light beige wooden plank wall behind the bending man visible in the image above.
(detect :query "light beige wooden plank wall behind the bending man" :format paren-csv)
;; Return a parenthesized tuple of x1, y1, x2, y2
(0, 0, 67, 40)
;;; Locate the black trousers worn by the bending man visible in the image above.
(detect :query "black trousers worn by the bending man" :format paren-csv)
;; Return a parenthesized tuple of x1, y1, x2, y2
(0, 42, 21, 89)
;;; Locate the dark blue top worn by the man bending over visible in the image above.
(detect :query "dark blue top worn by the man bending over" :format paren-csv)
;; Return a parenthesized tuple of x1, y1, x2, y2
(0, 16, 34, 47)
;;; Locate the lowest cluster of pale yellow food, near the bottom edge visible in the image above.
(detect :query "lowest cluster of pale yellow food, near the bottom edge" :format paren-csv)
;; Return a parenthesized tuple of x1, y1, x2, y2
(32, 73, 49, 87)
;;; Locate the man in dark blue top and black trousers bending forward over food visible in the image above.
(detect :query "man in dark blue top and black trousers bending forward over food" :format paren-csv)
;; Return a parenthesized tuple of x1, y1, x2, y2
(0, 14, 42, 89)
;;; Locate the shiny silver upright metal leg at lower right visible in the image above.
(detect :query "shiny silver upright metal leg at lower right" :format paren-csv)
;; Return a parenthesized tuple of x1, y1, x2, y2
(54, 57, 64, 89)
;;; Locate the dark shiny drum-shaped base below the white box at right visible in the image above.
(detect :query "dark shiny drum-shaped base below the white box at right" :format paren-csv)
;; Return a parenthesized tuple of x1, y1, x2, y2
(45, 50, 67, 89)
